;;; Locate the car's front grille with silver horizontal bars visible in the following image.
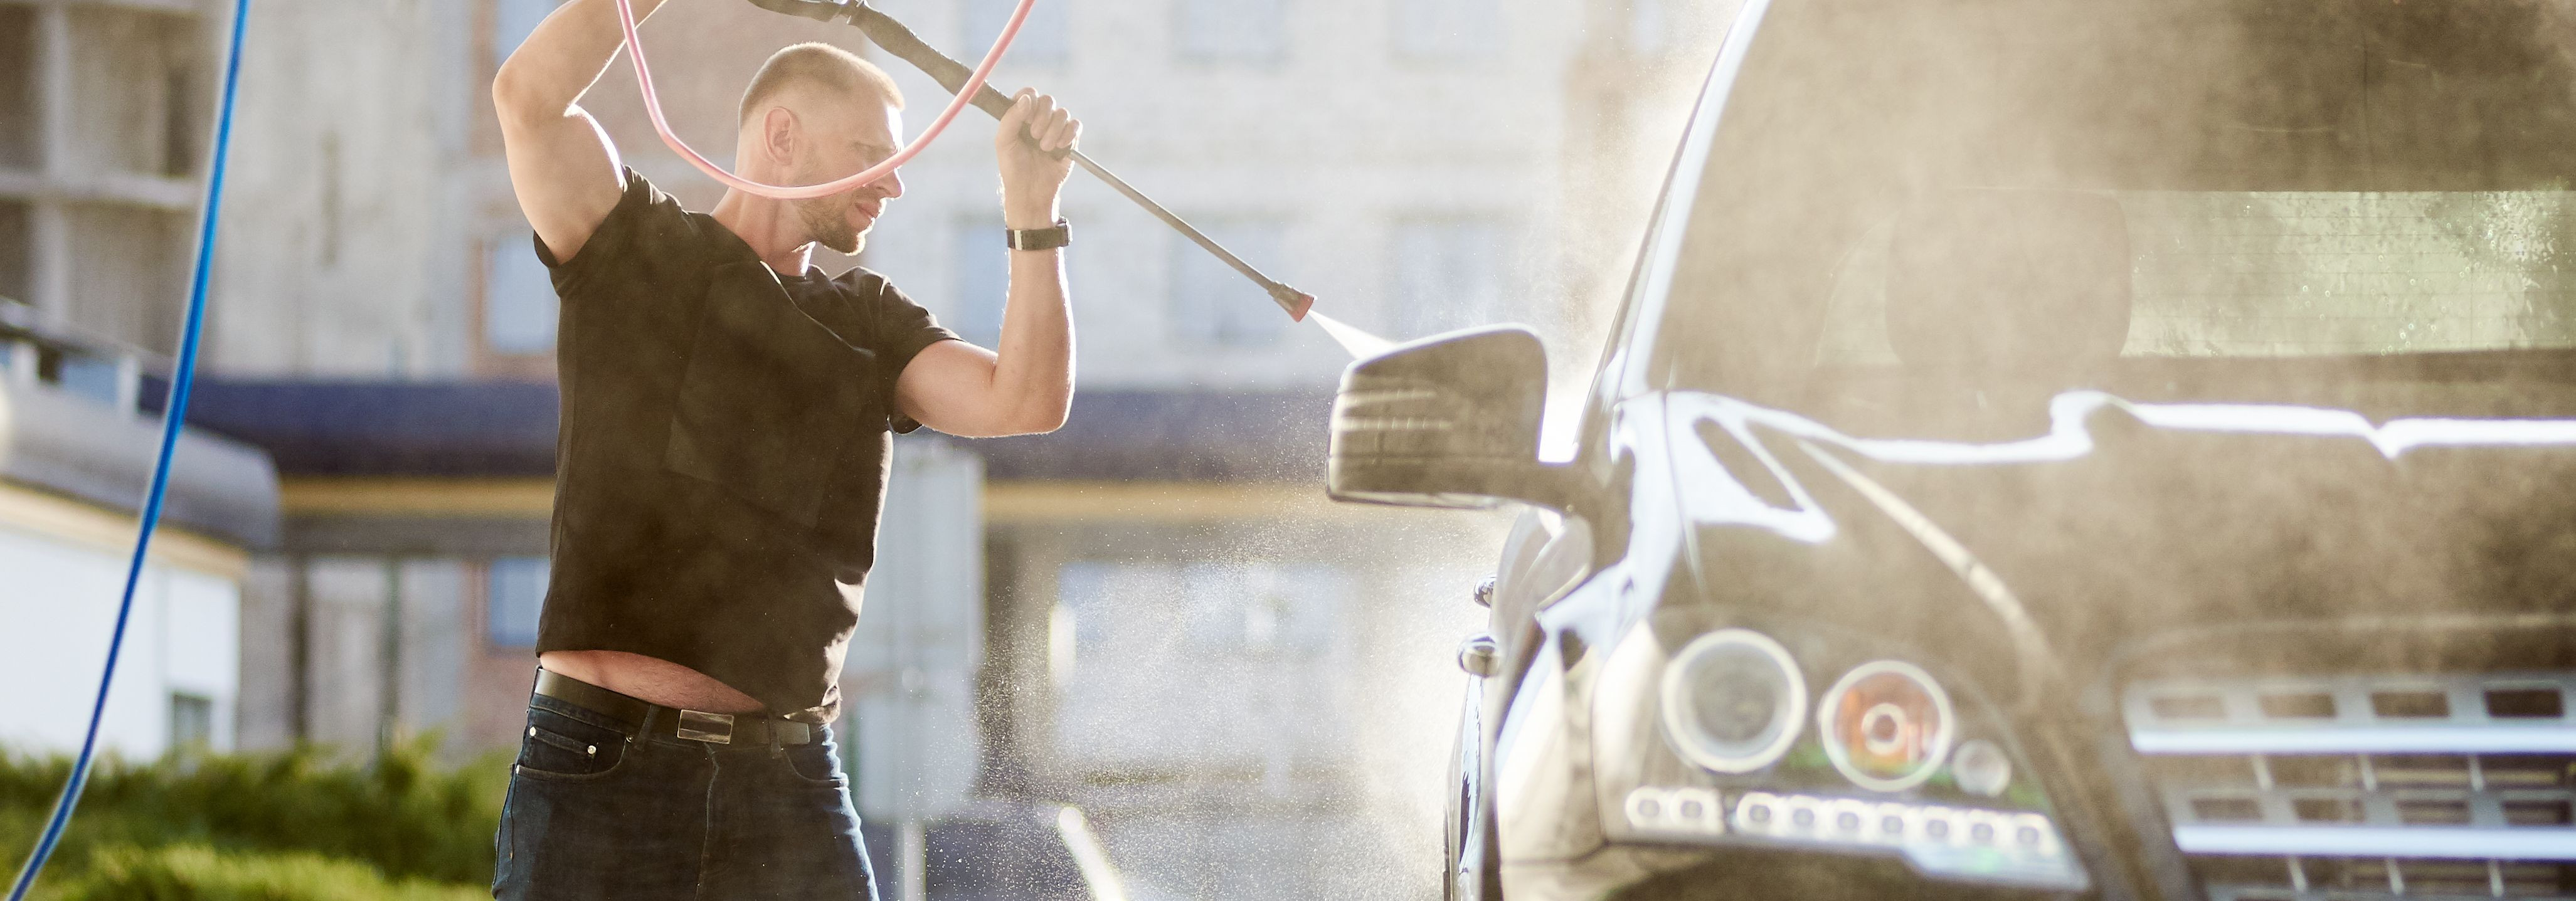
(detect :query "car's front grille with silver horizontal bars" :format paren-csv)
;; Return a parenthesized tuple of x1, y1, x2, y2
(2120, 675, 2576, 901)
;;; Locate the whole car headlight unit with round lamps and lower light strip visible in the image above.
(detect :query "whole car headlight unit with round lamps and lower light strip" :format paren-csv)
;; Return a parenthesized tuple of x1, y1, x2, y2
(1594, 626, 2089, 891)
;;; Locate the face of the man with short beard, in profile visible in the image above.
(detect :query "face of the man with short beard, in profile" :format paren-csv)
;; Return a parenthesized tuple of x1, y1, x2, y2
(793, 98, 904, 252)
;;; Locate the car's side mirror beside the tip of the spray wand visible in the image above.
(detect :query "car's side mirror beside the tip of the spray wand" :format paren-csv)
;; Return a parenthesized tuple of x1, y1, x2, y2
(1324, 324, 1566, 510)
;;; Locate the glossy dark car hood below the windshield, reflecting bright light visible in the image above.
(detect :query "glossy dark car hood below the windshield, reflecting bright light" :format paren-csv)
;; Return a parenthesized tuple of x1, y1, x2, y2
(1667, 391, 2576, 669)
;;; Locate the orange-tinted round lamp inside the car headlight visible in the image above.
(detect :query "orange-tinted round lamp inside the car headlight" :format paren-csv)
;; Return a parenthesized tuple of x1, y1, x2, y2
(1816, 659, 1955, 790)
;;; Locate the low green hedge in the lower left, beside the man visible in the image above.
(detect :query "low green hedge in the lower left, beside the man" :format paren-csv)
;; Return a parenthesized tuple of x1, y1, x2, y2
(0, 739, 510, 901)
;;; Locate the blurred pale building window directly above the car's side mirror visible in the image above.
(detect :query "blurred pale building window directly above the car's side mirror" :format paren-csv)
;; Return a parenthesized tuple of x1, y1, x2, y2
(1386, 219, 1504, 337)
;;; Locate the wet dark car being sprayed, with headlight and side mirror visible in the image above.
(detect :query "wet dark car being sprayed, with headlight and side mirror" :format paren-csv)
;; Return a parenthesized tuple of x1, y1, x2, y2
(1329, 0, 2576, 901)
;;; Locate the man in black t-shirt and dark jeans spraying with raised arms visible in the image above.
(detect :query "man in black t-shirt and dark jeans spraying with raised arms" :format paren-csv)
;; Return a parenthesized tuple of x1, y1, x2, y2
(492, 0, 1082, 901)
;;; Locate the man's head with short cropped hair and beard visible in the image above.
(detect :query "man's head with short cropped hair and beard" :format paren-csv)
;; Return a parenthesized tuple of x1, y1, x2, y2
(737, 44, 904, 252)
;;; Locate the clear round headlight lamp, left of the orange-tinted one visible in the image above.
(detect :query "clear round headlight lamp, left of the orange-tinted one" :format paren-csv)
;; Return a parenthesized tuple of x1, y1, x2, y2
(1664, 628, 1806, 772)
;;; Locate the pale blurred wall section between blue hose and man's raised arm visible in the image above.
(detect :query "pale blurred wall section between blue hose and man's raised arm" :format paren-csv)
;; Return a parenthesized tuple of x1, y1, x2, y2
(209, 0, 487, 379)
